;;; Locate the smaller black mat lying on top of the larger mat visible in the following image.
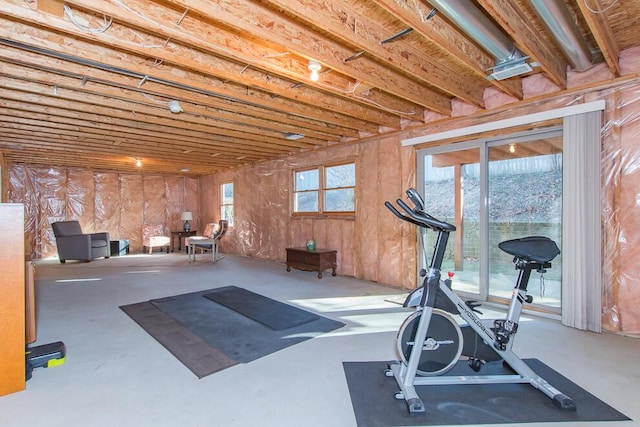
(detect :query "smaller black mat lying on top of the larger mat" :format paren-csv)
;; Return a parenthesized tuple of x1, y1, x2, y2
(204, 286, 319, 331)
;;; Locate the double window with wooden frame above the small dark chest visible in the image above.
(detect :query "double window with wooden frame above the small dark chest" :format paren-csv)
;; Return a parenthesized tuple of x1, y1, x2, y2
(293, 163, 356, 215)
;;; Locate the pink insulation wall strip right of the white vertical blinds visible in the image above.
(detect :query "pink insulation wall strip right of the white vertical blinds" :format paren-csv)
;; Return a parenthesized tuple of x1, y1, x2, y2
(602, 82, 640, 334)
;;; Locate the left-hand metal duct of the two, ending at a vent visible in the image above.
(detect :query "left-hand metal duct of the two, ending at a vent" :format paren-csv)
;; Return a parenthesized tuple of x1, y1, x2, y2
(427, 0, 525, 65)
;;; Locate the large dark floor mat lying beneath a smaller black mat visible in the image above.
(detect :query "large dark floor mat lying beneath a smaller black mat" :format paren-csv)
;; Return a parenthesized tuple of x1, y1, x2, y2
(120, 288, 344, 378)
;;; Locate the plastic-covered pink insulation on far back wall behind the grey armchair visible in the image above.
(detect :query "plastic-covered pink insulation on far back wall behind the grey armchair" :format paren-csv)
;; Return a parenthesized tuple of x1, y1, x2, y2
(9, 165, 199, 258)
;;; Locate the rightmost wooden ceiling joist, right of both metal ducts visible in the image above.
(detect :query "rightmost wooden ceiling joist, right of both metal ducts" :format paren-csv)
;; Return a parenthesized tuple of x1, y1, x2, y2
(576, 0, 620, 77)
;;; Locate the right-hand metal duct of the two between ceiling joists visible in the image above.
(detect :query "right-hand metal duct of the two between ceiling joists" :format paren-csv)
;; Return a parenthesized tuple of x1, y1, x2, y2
(529, 0, 594, 71)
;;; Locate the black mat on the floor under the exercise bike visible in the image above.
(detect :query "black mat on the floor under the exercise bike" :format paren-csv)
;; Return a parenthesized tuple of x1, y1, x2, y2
(343, 359, 629, 427)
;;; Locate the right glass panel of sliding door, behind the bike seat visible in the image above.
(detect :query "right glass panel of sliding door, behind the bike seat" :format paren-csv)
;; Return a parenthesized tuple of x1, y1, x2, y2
(487, 132, 562, 312)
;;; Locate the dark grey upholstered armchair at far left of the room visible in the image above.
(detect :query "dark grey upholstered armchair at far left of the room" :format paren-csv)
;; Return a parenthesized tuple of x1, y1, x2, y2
(51, 221, 111, 264)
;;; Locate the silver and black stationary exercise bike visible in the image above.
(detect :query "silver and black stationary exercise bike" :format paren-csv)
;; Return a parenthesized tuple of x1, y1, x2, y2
(385, 188, 576, 415)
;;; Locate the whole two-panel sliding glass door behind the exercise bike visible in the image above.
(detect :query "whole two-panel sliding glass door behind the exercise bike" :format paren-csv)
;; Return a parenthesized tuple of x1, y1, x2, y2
(418, 128, 562, 313)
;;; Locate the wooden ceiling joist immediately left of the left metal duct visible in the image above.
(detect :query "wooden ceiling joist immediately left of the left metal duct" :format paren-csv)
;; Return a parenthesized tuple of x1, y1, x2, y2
(373, 0, 523, 99)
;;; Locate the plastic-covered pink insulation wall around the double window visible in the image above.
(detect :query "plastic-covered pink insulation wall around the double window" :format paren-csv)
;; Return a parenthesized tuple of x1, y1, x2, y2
(200, 136, 416, 288)
